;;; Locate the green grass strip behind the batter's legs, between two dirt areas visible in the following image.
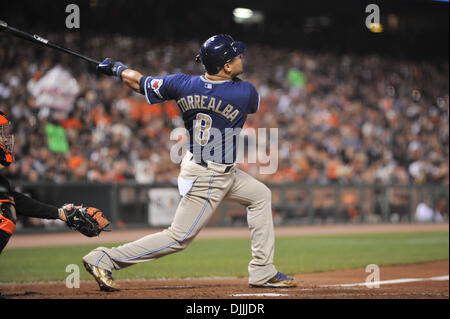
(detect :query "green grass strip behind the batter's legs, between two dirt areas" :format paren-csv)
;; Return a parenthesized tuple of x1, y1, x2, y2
(0, 232, 449, 283)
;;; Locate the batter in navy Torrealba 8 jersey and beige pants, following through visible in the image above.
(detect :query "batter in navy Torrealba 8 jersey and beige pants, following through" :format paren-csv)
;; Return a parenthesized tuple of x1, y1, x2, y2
(83, 34, 296, 291)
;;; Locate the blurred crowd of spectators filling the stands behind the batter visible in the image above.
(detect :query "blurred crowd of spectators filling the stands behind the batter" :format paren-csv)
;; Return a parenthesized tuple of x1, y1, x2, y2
(0, 33, 449, 188)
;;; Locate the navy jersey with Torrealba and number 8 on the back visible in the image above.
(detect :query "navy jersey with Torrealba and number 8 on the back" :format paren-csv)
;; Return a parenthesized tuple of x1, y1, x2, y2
(141, 74, 260, 164)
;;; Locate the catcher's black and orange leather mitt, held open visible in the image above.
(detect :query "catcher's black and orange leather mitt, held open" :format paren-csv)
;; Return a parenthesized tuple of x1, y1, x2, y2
(61, 204, 110, 237)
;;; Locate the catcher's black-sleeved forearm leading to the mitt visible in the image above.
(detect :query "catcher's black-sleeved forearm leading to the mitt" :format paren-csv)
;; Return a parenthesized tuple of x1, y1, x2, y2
(12, 192, 59, 219)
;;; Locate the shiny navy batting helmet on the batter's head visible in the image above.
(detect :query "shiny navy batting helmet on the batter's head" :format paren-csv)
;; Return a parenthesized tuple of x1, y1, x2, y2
(196, 34, 245, 75)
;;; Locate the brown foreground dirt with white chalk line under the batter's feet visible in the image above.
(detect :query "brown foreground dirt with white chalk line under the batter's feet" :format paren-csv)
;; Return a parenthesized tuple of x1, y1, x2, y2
(0, 261, 449, 299)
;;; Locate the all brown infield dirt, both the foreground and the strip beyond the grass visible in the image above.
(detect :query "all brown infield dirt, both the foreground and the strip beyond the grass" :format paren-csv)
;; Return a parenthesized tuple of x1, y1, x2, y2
(0, 224, 449, 299)
